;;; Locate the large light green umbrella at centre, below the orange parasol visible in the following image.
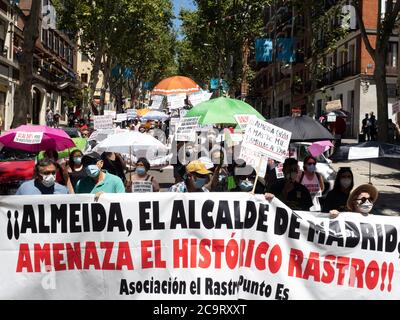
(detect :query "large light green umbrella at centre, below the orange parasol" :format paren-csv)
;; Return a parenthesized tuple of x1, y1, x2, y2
(185, 97, 265, 125)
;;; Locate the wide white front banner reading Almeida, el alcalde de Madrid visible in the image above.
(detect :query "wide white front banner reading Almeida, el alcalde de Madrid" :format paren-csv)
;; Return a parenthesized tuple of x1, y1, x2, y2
(0, 192, 400, 300)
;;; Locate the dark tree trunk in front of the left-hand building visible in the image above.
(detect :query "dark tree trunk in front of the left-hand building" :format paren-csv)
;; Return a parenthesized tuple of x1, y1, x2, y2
(11, 1, 42, 128)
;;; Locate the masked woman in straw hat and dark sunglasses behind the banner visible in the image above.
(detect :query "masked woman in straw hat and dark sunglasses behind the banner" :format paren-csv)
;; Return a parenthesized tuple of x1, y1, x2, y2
(331, 184, 379, 218)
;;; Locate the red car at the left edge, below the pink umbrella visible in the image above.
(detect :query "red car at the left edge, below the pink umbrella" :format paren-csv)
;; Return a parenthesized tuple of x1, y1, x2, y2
(0, 147, 36, 195)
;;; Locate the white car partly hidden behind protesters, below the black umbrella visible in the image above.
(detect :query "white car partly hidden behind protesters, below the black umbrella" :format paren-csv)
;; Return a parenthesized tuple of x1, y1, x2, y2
(289, 142, 336, 197)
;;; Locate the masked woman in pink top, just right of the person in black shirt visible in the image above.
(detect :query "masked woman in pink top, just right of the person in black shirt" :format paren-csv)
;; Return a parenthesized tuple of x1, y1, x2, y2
(298, 156, 325, 211)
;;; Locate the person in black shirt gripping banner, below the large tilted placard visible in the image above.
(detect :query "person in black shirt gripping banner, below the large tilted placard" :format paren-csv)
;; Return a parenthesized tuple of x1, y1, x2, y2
(265, 158, 313, 211)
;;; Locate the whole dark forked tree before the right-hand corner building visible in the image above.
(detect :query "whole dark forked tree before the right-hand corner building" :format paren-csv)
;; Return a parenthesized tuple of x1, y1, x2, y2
(352, 0, 400, 142)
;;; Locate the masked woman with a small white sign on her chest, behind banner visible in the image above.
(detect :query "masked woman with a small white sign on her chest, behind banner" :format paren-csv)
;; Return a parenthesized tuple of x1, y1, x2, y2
(132, 158, 160, 192)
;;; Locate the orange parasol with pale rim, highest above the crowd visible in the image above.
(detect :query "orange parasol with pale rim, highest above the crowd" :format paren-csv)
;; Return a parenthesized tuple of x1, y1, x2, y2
(152, 76, 201, 95)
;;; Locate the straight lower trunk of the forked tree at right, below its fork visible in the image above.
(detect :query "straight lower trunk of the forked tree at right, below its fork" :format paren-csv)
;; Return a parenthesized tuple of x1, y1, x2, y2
(374, 52, 388, 142)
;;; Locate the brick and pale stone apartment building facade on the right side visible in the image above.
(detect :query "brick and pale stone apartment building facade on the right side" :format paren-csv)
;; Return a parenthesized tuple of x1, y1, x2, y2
(253, 0, 400, 138)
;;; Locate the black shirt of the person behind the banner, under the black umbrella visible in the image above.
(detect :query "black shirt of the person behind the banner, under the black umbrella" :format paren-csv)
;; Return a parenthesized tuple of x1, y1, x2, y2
(269, 179, 313, 211)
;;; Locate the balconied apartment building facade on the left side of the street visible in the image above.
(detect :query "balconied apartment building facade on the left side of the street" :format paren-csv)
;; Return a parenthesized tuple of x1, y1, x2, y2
(0, 0, 80, 130)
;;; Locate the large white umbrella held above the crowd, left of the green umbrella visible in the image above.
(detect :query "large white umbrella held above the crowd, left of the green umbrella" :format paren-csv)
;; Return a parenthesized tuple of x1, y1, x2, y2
(93, 131, 168, 154)
